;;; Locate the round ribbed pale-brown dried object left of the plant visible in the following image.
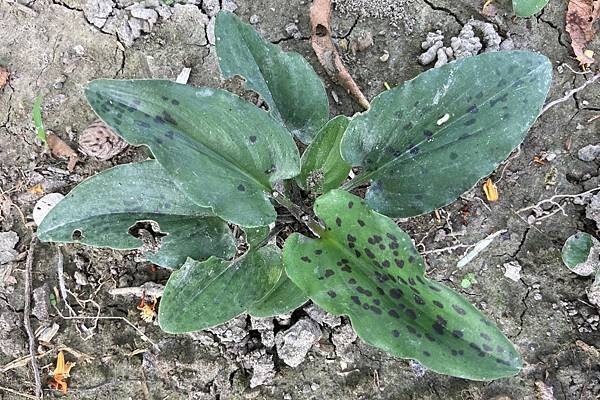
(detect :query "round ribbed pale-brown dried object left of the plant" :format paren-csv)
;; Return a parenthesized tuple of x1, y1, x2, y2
(79, 120, 127, 161)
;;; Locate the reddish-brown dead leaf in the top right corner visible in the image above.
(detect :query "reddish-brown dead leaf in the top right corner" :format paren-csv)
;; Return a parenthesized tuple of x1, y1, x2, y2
(566, 0, 600, 68)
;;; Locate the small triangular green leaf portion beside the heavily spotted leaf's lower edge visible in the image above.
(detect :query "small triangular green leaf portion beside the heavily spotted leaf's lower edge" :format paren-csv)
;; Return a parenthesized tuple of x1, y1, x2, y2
(248, 271, 308, 318)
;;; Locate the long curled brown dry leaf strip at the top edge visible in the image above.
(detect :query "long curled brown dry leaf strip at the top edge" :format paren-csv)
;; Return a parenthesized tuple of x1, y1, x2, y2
(310, 0, 369, 110)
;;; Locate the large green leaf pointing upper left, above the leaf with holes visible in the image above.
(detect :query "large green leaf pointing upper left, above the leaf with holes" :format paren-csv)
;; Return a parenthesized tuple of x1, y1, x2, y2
(86, 80, 300, 227)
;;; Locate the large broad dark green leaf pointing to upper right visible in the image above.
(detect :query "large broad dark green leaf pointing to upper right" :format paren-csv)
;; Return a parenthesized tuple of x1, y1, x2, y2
(341, 51, 552, 217)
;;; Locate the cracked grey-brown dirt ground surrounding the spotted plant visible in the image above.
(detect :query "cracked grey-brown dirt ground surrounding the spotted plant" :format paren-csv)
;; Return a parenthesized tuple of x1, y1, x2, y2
(0, 0, 600, 400)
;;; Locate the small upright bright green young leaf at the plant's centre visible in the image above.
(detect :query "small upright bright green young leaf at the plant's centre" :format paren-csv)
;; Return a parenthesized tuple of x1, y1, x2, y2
(296, 115, 350, 193)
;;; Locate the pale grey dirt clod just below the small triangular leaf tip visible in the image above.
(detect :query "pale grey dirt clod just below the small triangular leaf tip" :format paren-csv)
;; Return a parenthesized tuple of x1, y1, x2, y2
(275, 318, 321, 367)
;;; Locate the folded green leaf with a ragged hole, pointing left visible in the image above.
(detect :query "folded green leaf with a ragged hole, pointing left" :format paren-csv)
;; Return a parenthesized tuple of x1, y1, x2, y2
(38, 160, 235, 268)
